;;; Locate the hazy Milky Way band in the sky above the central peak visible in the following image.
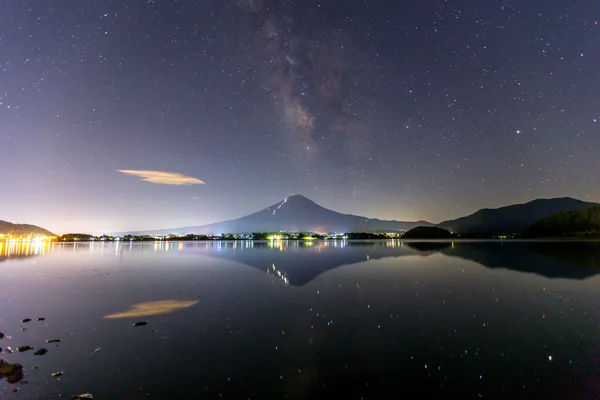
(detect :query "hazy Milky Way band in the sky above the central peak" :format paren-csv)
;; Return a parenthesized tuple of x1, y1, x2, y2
(238, 0, 368, 163)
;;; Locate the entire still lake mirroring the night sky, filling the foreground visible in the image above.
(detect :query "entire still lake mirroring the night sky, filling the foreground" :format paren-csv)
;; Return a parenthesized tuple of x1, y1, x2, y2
(0, 241, 600, 400)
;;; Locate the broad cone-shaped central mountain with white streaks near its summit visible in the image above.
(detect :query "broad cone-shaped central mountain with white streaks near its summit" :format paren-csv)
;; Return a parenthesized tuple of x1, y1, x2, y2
(135, 195, 432, 235)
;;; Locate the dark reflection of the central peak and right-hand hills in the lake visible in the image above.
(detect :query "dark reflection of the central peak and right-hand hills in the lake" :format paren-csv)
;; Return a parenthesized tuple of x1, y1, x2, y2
(189, 240, 600, 286)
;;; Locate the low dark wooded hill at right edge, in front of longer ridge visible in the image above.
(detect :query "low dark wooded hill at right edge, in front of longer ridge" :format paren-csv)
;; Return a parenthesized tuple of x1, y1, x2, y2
(523, 207, 600, 237)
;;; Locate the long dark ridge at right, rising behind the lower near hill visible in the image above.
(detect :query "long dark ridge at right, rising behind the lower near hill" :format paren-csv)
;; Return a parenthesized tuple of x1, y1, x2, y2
(437, 197, 599, 235)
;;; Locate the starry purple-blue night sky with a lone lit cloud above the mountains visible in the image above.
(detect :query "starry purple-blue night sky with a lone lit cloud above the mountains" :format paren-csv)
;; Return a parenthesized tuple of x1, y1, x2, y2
(0, 0, 600, 233)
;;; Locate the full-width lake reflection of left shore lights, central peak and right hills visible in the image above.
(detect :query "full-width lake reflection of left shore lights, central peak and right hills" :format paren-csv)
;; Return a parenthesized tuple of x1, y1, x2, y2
(7, 240, 600, 286)
